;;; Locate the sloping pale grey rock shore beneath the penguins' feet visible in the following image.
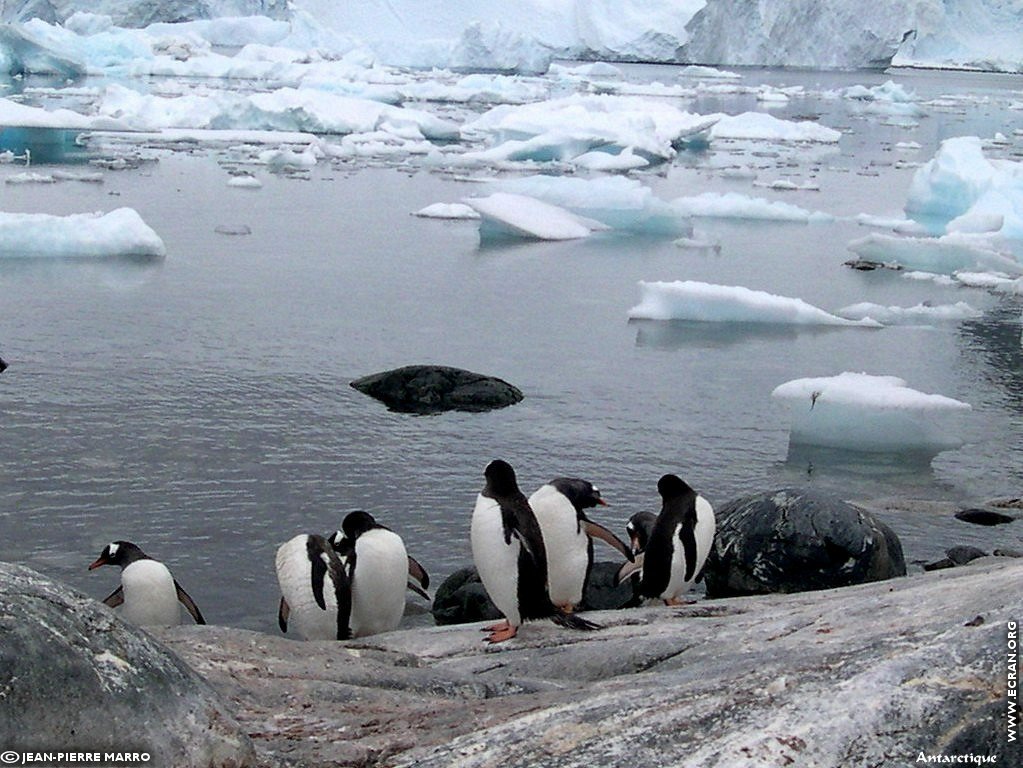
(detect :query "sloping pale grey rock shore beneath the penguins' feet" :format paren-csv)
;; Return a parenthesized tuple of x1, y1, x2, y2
(152, 558, 1023, 768)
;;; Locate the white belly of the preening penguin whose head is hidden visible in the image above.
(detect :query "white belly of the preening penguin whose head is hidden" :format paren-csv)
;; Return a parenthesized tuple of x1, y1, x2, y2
(276, 534, 338, 640)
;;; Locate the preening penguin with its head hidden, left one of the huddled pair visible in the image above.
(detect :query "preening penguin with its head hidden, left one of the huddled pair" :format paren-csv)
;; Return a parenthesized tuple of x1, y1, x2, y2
(276, 534, 352, 640)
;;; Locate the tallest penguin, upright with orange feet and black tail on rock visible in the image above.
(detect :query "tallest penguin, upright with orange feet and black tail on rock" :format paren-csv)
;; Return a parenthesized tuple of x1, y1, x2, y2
(471, 459, 597, 642)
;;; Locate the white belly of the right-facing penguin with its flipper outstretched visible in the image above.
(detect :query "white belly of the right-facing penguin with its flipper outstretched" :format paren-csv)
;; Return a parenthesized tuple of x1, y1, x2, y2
(529, 484, 589, 606)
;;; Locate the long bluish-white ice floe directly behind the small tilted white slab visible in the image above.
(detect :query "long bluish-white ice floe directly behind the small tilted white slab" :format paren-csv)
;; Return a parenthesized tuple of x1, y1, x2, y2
(497, 175, 693, 237)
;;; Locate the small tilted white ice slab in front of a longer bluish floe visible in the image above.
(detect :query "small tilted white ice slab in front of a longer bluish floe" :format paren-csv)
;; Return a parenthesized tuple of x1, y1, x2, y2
(465, 192, 608, 240)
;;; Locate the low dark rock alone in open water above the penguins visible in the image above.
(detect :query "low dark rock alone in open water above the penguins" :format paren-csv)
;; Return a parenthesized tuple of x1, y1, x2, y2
(351, 365, 523, 413)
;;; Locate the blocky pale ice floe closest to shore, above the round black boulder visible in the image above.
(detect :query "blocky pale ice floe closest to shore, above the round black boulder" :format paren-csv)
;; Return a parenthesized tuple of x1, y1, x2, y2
(771, 371, 970, 454)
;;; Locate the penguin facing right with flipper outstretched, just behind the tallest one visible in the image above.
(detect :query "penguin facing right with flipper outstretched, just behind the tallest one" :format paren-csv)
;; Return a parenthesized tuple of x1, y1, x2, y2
(529, 478, 632, 613)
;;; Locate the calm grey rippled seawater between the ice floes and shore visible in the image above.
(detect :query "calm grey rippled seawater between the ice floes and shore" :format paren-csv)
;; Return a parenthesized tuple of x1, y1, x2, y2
(0, 67, 1023, 631)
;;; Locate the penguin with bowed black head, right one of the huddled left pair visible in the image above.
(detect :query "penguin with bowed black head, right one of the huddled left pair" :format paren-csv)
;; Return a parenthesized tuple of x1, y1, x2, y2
(330, 510, 430, 637)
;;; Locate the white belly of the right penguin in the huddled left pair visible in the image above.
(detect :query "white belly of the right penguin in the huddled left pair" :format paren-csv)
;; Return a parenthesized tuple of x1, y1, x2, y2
(351, 529, 408, 637)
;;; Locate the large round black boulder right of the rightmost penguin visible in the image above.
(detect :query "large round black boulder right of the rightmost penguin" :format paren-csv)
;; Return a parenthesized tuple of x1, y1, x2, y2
(704, 488, 905, 597)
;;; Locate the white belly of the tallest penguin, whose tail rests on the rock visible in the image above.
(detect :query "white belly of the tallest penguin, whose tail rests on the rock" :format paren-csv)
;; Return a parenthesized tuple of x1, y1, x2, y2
(470, 494, 522, 627)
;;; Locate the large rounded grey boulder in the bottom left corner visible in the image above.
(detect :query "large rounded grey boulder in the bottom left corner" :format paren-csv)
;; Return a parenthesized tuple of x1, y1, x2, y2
(0, 562, 256, 768)
